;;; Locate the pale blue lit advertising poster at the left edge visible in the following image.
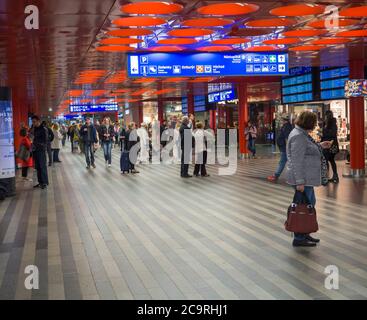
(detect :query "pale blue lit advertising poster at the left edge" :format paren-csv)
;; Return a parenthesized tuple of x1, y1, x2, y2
(0, 101, 15, 179)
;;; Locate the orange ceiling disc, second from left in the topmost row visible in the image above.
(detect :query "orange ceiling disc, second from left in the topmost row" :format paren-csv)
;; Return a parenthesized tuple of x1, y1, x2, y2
(197, 2, 259, 16)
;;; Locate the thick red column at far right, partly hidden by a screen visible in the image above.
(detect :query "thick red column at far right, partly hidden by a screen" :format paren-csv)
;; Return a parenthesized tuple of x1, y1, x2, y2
(349, 59, 365, 177)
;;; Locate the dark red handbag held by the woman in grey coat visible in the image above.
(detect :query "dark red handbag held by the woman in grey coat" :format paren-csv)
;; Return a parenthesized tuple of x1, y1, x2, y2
(284, 191, 319, 233)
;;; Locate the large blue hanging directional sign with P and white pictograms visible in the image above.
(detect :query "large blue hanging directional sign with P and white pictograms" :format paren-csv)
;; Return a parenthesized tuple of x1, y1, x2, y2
(127, 52, 288, 78)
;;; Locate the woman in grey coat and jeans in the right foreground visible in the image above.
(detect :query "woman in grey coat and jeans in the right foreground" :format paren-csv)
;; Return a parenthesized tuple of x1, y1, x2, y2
(287, 111, 331, 247)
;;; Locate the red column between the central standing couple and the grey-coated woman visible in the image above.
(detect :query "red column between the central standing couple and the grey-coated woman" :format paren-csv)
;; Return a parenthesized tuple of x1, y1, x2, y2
(238, 82, 249, 155)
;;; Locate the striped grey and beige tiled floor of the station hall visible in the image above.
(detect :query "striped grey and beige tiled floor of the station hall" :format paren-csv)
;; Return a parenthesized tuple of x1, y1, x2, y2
(0, 145, 367, 300)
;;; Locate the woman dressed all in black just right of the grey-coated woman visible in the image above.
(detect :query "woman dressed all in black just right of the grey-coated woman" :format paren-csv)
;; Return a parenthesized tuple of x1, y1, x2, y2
(321, 110, 339, 183)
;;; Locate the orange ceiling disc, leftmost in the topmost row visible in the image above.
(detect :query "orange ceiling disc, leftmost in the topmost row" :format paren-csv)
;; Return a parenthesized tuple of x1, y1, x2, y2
(121, 1, 183, 14)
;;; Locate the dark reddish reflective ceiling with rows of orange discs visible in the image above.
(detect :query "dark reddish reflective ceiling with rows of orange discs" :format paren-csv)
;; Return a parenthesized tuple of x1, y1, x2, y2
(0, 0, 367, 114)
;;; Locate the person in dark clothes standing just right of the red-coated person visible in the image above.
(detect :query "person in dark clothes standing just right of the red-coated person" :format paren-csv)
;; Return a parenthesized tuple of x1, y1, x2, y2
(32, 116, 49, 189)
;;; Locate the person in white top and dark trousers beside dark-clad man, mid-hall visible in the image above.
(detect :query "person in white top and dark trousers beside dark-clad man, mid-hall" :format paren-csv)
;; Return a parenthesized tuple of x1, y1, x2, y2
(193, 122, 209, 177)
